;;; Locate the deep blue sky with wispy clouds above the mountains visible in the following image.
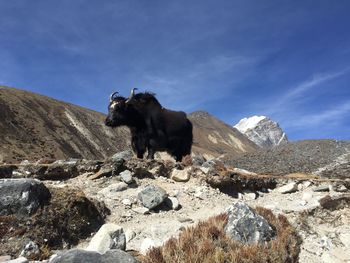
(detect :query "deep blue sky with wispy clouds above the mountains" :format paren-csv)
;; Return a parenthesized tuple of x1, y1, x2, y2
(0, 0, 350, 140)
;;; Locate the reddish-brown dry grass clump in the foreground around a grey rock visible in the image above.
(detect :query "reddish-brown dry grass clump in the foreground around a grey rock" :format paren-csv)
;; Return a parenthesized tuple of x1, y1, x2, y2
(140, 208, 301, 263)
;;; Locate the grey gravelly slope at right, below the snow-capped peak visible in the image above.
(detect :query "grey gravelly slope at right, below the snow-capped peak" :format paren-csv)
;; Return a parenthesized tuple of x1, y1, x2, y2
(223, 140, 350, 178)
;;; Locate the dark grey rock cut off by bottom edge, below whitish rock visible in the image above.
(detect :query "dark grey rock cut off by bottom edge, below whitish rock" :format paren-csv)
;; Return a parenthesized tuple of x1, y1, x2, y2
(50, 249, 137, 263)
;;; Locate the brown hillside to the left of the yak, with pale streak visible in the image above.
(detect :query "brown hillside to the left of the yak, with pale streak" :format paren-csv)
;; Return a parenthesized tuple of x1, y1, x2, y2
(0, 87, 129, 163)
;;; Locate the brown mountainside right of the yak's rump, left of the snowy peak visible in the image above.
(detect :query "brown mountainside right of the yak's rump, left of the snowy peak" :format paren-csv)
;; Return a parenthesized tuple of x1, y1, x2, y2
(188, 111, 259, 159)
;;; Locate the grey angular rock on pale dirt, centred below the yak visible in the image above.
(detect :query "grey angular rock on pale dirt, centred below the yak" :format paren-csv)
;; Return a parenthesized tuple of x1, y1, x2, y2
(137, 185, 168, 209)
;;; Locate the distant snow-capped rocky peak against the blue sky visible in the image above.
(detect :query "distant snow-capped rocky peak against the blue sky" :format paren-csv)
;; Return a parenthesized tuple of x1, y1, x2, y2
(234, 116, 288, 148)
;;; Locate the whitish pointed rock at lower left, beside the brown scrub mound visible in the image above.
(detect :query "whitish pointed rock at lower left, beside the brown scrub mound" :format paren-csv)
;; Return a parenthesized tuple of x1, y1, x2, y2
(86, 223, 126, 254)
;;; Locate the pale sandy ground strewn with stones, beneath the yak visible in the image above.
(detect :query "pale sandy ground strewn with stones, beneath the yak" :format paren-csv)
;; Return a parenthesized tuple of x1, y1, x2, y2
(0, 152, 350, 263)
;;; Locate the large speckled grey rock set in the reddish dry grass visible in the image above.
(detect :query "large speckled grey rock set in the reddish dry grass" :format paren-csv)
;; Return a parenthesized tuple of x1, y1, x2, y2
(225, 202, 276, 244)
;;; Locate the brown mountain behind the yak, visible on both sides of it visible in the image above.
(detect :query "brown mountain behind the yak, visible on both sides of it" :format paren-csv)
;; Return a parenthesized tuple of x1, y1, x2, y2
(0, 87, 258, 163)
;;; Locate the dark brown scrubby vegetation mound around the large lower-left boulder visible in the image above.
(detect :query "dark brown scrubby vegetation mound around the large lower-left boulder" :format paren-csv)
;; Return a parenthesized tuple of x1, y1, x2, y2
(0, 189, 108, 259)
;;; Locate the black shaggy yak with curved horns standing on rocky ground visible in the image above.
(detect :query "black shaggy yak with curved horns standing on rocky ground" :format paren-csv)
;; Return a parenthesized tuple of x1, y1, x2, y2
(106, 89, 193, 162)
